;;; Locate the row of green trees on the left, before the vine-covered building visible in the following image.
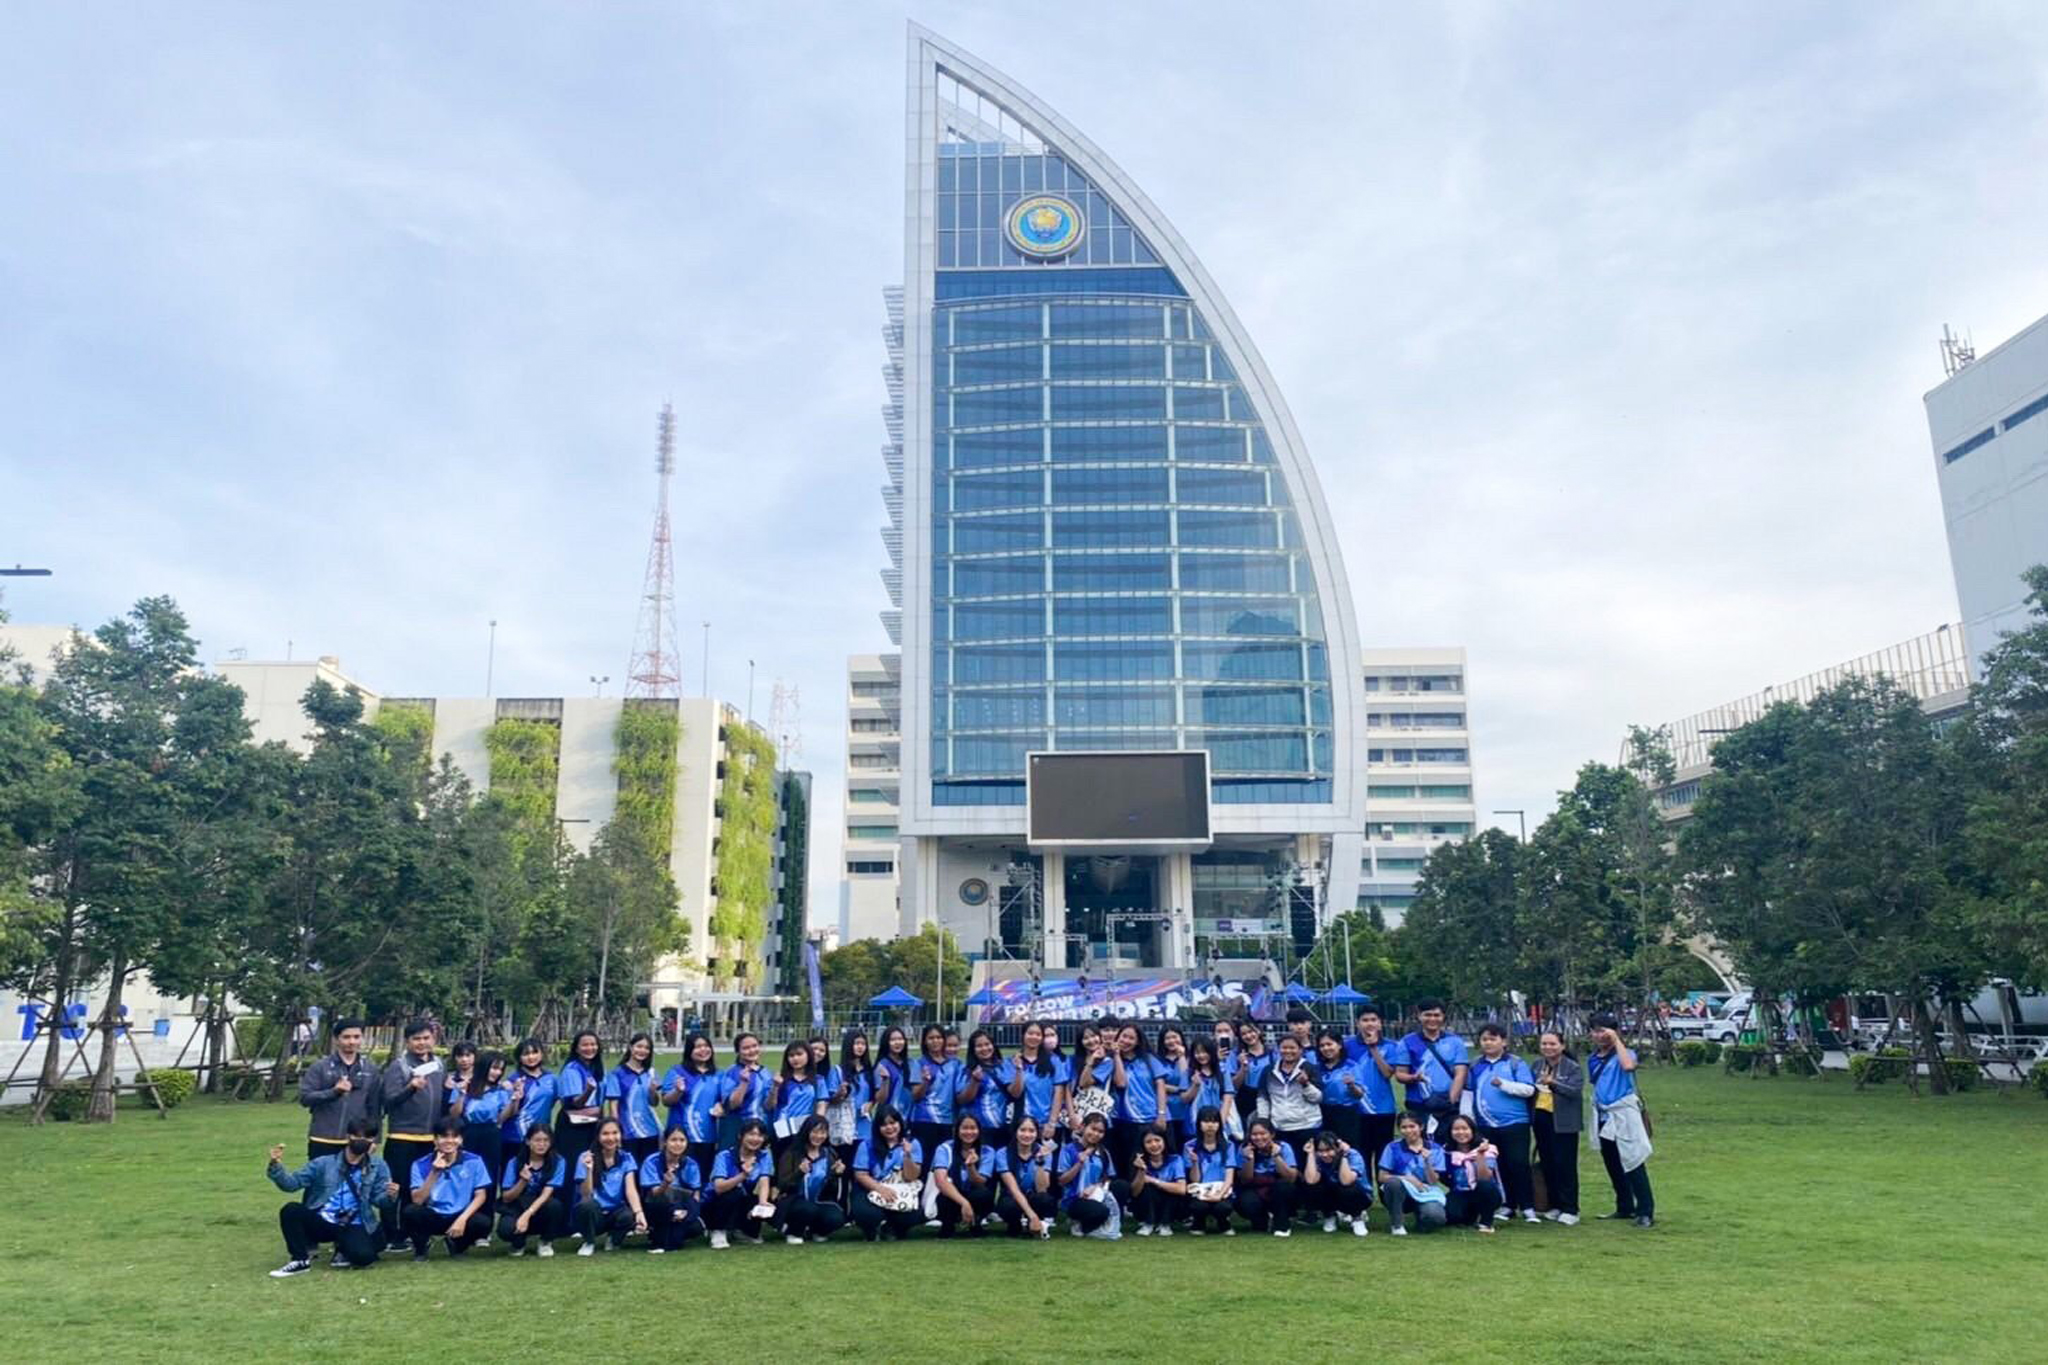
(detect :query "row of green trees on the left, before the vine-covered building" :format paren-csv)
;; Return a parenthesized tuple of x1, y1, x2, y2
(0, 598, 682, 1119)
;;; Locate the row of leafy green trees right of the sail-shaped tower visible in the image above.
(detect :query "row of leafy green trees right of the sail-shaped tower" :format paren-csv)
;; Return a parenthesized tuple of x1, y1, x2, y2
(1359, 569, 2048, 1089)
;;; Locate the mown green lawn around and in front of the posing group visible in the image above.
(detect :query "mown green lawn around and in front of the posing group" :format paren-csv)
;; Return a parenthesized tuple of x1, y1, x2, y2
(0, 1070, 2048, 1365)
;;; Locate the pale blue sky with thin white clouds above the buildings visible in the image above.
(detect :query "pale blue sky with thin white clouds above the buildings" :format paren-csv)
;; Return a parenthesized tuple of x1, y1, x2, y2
(0, 0, 2048, 923)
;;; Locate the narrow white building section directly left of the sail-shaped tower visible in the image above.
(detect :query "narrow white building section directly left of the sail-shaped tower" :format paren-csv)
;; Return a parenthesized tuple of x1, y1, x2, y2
(840, 655, 903, 943)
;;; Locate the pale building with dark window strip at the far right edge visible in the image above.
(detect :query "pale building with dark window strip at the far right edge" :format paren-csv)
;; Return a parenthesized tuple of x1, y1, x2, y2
(1927, 317, 2048, 677)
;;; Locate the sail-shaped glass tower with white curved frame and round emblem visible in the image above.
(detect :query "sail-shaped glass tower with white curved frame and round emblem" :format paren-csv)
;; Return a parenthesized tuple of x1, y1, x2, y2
(883, 27, 1366, 968)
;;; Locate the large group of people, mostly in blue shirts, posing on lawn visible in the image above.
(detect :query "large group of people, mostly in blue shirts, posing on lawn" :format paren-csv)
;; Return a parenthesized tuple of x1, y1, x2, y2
(268, 1001, 1655, 1277)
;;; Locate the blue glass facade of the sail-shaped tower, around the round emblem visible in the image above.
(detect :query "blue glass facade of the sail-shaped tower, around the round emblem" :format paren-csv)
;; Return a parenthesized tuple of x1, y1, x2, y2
(930, 141, 1333, 806)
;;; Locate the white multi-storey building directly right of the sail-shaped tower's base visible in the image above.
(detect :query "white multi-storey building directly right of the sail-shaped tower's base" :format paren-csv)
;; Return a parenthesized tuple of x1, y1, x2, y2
(1358, 649, 1477, 925)
